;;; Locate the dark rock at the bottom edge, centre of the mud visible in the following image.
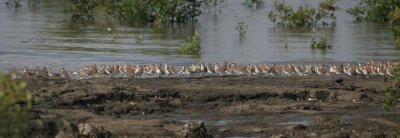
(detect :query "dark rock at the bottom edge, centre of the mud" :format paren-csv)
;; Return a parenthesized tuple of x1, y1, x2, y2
(176, 121, 212, 138)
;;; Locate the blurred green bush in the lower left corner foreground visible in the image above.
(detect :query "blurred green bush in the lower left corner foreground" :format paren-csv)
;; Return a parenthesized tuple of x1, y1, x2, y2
(0, 75, 32, 137)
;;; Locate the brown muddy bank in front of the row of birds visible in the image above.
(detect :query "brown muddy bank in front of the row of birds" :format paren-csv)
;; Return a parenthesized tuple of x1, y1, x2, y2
(26, 76, 400, 137)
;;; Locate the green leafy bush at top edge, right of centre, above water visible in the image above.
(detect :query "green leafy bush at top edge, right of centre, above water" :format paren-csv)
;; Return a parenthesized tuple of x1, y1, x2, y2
(268, 0, 338, 27)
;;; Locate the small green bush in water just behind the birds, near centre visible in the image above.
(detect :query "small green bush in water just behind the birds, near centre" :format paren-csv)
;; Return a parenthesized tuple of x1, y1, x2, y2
(180, 30, 201, 55)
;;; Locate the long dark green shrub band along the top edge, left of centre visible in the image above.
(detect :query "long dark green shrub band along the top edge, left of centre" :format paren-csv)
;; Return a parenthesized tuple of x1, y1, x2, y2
(68, 0, 201, 22)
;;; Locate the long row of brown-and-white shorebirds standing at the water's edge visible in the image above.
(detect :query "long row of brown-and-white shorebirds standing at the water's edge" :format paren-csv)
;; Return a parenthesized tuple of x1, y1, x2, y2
(10, 60, 398, 79)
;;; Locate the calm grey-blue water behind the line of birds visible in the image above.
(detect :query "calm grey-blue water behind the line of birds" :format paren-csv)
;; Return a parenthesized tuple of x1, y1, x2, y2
(0, 0, 399, 70)
